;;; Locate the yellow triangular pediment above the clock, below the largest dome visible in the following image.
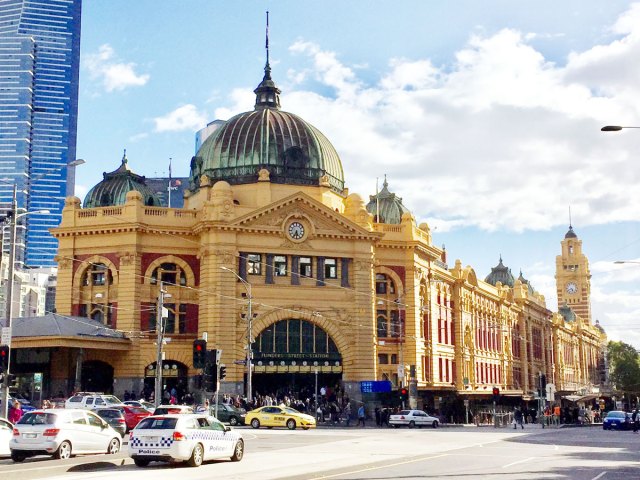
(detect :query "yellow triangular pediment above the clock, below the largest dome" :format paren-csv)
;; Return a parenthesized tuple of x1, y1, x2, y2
(229, 192, 379, 238)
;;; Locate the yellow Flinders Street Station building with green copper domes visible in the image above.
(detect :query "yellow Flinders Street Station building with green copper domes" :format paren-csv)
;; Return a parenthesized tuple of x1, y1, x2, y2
(12, 56, 606, 416)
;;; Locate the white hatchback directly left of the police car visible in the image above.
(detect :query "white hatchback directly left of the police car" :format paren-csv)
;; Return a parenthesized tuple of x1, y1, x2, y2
(9, 408, 122, 462)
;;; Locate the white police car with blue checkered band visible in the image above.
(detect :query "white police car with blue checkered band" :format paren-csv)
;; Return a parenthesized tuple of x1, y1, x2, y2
(129, 414, 244, 467)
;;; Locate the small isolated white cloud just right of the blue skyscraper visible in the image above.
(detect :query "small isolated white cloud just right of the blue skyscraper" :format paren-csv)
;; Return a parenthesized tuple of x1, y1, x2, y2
(84, 44, 150, 92)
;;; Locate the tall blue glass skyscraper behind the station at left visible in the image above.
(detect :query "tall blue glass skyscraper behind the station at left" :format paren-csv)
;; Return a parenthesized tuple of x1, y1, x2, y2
(0, 0, 81, 267)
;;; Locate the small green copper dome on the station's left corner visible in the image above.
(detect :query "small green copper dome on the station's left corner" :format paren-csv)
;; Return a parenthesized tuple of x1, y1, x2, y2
(84, 150, 160, 208)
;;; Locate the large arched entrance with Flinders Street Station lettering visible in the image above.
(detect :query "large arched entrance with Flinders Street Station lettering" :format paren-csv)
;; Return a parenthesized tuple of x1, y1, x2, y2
(252, 319, 342, 400)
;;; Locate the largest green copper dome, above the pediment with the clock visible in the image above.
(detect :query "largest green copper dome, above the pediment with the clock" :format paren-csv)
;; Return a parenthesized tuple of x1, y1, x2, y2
(189, 63, 344, 192)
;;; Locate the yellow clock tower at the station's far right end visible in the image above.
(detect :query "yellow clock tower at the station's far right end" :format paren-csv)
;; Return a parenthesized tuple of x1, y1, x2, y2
(556, 225, 591, 323)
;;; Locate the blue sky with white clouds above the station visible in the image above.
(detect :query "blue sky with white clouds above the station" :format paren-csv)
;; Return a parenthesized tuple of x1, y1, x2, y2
(76, 0, 640, 348)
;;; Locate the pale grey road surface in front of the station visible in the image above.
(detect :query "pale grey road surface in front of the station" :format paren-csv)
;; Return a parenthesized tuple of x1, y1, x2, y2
(0, 426, 640, 480)
